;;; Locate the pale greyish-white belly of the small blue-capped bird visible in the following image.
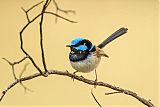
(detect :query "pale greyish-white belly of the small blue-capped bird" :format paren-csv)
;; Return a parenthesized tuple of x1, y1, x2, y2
(70, 55, 101, 73)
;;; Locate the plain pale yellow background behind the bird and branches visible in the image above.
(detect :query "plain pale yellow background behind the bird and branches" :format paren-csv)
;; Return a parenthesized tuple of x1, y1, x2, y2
(0, 0, 160, 106)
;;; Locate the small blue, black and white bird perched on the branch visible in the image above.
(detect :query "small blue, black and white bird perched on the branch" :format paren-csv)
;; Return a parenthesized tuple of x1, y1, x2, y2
(66, 27, 128, 81)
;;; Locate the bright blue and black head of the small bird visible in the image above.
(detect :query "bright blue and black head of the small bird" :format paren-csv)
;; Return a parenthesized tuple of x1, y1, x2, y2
(66, 38, 95, 53)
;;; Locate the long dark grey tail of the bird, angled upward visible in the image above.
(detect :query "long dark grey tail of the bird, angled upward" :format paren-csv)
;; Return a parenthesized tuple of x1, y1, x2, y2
(98, 27, 128, 48)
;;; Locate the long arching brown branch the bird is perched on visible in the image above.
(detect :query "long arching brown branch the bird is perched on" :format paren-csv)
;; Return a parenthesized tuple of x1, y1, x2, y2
(0, 70, 156, 107)
